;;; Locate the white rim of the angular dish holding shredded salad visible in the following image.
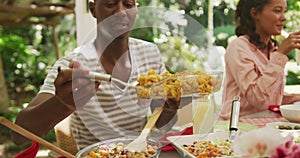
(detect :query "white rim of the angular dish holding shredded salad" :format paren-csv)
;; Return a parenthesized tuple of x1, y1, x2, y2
(167, 132, 237, 158)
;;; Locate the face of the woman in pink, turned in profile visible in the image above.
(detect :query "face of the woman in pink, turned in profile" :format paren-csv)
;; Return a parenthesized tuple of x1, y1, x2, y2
(251, 0, 286, 37)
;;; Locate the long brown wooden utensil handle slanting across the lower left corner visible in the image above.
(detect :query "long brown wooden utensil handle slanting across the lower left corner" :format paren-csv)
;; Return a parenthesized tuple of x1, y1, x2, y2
(0, 116, 75, 158)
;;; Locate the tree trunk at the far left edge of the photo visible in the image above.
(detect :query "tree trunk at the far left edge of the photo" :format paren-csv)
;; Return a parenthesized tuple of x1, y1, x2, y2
(0, 57, 9, 113)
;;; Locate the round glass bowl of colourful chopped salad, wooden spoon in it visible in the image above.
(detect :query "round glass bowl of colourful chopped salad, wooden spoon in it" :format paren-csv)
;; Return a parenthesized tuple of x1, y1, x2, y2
(76, 136, 162, 158)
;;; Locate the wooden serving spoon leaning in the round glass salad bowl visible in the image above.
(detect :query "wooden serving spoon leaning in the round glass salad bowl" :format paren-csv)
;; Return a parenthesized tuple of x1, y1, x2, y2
(125, 107, 163, 152)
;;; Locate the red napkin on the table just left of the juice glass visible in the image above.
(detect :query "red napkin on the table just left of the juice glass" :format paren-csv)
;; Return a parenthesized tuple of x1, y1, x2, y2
(160, 127, 193, 151)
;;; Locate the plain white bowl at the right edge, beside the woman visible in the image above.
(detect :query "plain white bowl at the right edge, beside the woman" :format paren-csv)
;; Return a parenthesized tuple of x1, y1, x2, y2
(280, 104, 300, 123)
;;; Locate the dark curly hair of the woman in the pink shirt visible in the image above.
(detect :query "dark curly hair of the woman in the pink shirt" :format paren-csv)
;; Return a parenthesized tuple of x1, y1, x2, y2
(235, 0, 276, 49)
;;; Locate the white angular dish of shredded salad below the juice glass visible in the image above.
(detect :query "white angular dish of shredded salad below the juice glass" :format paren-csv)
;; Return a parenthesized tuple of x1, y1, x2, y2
(167, 132, 236, 158)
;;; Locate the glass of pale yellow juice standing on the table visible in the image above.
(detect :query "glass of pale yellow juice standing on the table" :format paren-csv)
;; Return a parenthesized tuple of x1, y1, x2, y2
(192, 94, 216, 134)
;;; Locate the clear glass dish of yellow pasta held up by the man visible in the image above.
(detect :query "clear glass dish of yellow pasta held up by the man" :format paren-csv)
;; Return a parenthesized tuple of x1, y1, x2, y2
(137, 70, 223, 99)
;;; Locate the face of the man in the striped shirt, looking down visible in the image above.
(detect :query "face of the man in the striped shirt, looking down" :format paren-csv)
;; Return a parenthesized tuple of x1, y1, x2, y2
(90, 0, 137, 39)
